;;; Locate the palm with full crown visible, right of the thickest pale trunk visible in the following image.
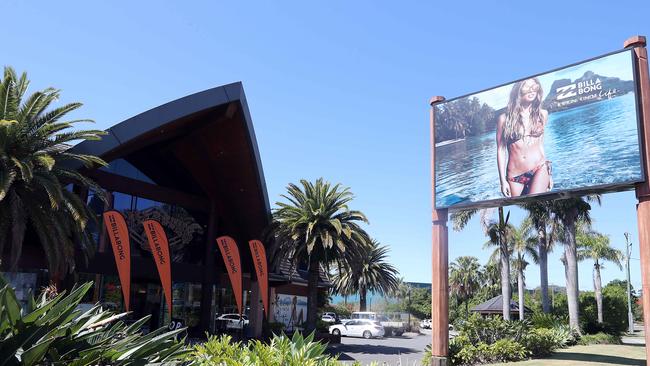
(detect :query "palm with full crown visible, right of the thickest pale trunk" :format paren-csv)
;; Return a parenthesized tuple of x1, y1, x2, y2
(576, 231, 623, 323)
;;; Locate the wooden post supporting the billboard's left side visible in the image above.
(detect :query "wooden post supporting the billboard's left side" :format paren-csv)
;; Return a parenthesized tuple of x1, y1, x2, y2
(429, 97, 449, 366)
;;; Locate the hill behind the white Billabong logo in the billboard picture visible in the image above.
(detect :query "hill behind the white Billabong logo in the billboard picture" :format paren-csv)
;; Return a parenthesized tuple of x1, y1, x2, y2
(542, 71, 634, 112)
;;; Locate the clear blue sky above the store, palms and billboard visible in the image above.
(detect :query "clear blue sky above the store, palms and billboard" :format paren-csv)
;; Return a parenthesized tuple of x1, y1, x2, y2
(5, 0, 650, 289)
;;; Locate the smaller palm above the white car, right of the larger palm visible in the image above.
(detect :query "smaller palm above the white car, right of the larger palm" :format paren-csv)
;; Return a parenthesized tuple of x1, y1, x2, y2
(333, 240, 400, 311)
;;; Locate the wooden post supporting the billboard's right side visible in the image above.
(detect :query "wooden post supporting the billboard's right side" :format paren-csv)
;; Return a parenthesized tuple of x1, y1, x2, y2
(624, 36, 650, 359)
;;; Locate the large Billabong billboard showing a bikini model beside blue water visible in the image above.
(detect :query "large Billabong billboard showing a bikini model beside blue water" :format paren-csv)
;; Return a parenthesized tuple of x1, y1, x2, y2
(433, 50, 644, 208)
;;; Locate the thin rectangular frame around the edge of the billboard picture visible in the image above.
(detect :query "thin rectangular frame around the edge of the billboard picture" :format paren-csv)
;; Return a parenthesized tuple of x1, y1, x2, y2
(431, 48, 647, 211)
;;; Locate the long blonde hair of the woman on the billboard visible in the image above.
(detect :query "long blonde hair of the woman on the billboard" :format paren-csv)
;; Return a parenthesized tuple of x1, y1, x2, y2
(502, 78, 544, 143)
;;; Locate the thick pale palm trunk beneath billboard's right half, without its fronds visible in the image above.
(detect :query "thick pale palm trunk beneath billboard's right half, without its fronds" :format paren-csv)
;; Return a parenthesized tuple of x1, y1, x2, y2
(564, 214, 580, 332)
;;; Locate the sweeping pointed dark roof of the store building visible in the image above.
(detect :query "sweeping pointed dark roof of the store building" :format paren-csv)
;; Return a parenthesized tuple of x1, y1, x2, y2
(73, 82, 270, 241)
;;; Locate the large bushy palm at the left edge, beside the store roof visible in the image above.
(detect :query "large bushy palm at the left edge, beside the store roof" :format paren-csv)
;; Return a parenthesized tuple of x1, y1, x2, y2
(0, 67, 106, 283)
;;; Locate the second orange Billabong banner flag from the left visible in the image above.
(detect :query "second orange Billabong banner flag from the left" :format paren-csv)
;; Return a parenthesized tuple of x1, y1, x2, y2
(142, 220, 172, 316)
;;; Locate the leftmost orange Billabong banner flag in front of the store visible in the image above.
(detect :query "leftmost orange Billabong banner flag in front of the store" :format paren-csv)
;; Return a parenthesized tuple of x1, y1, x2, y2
(102, 210, 131, 311)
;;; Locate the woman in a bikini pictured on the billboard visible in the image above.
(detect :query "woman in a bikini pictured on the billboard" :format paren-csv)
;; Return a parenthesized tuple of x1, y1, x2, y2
(497, 78, 553, 197)
